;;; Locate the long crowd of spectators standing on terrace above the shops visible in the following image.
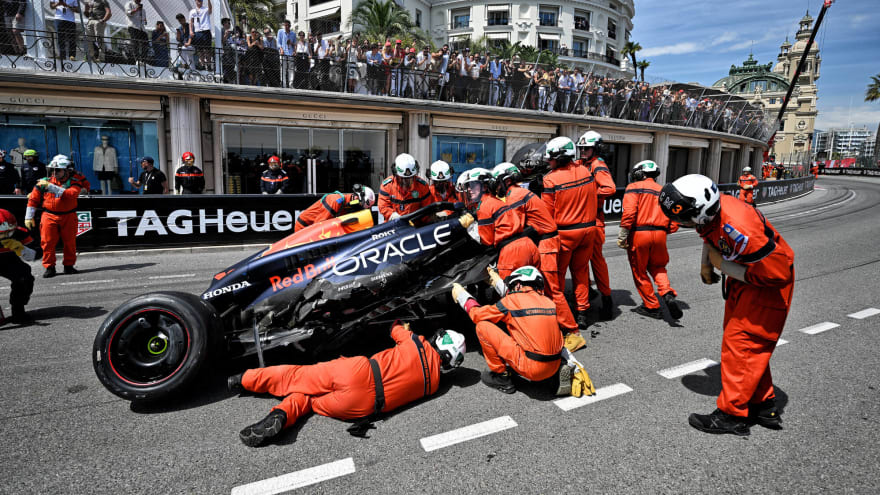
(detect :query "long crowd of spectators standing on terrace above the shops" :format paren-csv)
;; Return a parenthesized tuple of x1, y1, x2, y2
(0, 5, 771, 139)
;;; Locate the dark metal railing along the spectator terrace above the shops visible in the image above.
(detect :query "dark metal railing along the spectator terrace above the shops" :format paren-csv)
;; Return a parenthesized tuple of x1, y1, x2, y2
(0, 31, 776, 140)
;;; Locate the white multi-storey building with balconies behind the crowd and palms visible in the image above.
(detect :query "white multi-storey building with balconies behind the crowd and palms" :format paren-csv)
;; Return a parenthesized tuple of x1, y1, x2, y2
(287, 0, 635, 77)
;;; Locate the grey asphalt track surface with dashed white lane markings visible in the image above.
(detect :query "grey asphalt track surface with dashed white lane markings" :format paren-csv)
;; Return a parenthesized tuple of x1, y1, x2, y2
(0, 176, 880, 494)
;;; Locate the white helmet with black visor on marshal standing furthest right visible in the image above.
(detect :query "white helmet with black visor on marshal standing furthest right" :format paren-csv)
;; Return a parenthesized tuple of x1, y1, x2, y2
(658, 174, 721, 225)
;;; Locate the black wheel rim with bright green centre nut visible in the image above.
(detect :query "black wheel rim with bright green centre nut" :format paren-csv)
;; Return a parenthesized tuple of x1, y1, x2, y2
(107, 308, 190, 387)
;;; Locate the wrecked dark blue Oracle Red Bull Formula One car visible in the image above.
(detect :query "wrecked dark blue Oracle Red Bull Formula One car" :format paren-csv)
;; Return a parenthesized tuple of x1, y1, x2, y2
(98, 203, 495, 401)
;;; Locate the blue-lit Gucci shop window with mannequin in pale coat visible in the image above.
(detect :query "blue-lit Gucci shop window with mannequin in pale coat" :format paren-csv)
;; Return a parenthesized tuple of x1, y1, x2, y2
(0, 115, 159, 195)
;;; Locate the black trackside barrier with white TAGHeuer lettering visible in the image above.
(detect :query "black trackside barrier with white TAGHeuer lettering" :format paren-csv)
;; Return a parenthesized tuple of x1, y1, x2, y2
(0, 176, 814, 252)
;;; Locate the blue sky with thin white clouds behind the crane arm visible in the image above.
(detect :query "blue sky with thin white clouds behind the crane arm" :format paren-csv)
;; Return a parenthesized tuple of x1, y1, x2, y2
(631, 0, 880, 130)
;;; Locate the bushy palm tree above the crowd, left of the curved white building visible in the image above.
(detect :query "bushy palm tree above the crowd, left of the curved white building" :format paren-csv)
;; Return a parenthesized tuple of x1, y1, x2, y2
(346, 0, 433, 46)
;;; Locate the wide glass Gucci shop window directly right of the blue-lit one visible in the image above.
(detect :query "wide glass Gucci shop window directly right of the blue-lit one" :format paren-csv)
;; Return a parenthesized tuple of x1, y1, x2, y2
(223, 124, 387, 194)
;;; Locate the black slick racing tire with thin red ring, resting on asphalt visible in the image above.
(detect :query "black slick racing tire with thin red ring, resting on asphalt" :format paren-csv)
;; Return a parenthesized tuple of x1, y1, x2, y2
(92, 292, 216, 402)
